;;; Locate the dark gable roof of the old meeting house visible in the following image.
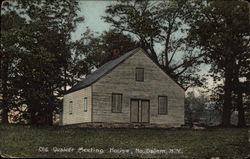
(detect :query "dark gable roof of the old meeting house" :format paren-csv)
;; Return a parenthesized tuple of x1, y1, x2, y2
(65, 48, 183, 94)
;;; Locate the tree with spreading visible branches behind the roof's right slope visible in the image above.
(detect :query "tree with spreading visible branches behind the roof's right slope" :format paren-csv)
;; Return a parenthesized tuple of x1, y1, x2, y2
(103, 0, 204, 89)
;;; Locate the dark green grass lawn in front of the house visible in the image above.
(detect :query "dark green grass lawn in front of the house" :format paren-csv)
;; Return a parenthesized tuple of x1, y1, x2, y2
(0, 124, 250, 159)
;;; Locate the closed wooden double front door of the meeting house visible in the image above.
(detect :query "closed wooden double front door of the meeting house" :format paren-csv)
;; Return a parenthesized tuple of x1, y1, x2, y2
(130, 99, 149, 123)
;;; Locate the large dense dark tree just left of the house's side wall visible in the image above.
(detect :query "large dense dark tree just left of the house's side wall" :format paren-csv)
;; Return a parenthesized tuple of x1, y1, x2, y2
(0, 1, 83, 124)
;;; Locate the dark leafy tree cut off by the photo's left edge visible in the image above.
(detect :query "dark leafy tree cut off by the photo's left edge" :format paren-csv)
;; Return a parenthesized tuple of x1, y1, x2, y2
(0, 5, 25, 123)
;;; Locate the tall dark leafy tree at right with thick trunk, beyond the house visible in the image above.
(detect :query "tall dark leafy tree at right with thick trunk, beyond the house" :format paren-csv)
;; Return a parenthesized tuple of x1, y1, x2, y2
(189, 0, 249, 127)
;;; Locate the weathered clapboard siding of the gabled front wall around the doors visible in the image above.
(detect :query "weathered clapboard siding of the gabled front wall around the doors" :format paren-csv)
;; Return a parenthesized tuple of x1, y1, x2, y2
(92, 50, 184, 125)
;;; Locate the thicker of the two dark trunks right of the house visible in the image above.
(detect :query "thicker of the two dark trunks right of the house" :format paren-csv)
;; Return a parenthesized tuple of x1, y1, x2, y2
(222, 66, 233, 127)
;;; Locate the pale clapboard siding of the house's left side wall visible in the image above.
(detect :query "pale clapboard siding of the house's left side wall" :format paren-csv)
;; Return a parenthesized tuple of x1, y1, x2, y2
(62, 86, 92, 125)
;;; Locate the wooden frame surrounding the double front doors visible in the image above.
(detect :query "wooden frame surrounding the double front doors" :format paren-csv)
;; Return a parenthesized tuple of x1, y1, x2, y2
(130, 98, 150, 124)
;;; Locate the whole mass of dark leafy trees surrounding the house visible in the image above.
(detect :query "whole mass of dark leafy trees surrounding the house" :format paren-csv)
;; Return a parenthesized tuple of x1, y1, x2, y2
(0, 0, 250, 127)
